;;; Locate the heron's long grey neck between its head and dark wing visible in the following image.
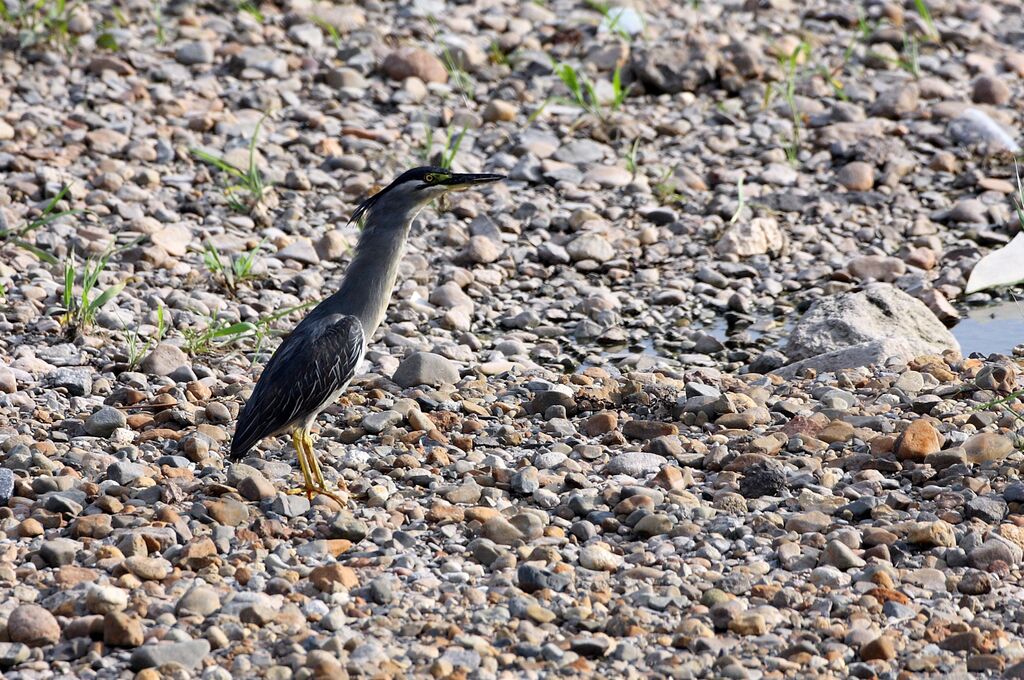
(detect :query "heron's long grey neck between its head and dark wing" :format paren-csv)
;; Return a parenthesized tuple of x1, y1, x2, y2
(332, 209, 419, 342)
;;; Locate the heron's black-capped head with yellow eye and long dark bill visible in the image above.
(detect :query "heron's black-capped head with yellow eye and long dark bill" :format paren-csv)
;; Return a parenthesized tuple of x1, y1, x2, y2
(351, 166, 505, 226)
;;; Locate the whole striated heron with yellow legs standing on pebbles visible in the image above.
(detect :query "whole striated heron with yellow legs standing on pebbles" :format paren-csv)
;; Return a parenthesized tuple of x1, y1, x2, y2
(230, 167, 504, 503)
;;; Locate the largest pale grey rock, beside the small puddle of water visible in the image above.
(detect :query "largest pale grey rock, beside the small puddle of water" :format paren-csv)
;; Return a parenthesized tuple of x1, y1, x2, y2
(776, 283, 959, 375)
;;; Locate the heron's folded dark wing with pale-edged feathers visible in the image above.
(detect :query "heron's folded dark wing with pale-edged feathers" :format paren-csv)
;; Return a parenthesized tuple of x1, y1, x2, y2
(230, 314, 365, 460)
